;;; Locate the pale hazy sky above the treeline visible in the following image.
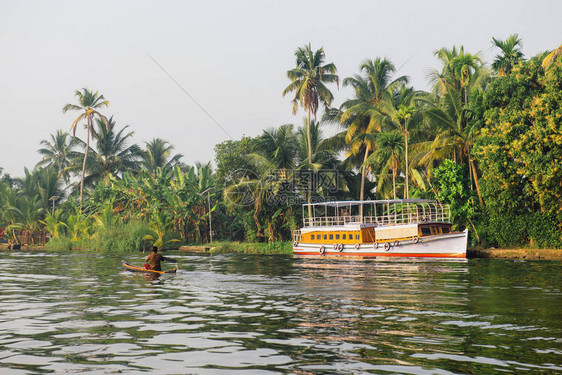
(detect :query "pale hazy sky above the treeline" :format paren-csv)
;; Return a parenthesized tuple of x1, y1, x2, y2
(0, 0, 562, 176)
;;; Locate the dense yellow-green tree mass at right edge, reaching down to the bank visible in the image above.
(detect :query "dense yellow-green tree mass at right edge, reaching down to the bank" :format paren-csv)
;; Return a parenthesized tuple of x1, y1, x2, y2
(474, 51, 562, 247)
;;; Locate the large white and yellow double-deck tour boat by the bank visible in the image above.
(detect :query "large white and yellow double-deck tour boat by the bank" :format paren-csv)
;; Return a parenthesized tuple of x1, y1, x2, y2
(293, 199, 468, 258)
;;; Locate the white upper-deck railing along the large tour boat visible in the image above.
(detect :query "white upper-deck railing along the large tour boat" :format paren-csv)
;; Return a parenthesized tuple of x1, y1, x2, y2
(303, 203, 451, 227)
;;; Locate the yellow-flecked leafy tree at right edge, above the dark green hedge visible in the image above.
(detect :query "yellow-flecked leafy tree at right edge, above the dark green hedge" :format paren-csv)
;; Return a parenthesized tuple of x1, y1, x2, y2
(475, 53, 562, 219)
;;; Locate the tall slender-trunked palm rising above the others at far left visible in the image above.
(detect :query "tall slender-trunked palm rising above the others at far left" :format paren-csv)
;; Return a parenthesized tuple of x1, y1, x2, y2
(62, 88, 109, 209)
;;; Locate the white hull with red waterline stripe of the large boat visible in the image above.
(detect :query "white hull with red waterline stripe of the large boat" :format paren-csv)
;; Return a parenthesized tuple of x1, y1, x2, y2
(293, 229, 468, 258)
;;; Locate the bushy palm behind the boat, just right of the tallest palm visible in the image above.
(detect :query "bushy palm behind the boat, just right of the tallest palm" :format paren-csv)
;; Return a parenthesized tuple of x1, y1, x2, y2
(340, 58, 408, 207)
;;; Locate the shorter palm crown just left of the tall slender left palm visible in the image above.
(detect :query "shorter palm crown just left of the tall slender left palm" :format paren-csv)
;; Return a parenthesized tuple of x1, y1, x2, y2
(37, 130, 78, 183)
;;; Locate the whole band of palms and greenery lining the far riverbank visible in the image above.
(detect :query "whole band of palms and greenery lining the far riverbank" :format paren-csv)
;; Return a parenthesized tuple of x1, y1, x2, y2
(0, 35, 562, 252)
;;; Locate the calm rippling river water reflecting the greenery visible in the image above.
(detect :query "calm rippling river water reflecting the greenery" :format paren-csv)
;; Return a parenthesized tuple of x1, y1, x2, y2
(0, 252, 562, 375)
